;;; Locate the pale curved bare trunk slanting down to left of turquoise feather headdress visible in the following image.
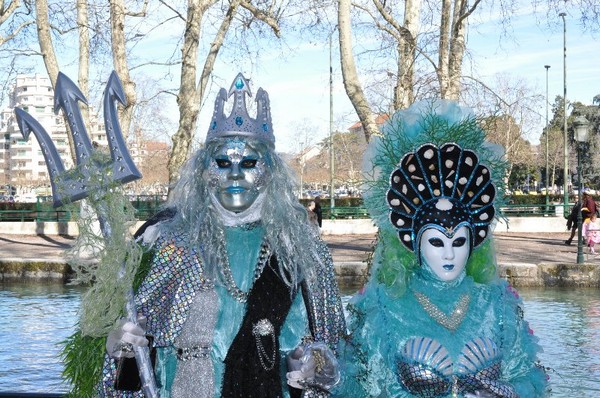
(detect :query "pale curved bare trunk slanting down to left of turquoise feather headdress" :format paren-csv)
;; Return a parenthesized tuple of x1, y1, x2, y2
(332, 0, 379, 142)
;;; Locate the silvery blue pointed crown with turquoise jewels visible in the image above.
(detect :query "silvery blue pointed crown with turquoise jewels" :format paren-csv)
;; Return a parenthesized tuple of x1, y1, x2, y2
(206, 73, 275, 146)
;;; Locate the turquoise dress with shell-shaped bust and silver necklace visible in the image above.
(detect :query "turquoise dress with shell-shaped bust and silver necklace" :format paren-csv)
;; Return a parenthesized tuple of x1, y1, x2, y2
(335, 269, 546, 398)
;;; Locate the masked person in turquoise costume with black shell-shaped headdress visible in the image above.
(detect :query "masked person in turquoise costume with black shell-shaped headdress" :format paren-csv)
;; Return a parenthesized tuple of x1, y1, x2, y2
(336, 100, 547, 398)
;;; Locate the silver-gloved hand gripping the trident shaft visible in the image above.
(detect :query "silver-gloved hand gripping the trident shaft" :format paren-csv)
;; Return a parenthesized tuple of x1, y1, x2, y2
(106, 315, 148, 358)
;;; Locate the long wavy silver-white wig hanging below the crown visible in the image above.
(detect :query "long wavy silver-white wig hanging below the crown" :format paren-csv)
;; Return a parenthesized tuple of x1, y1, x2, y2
(162, 139, 318, 293)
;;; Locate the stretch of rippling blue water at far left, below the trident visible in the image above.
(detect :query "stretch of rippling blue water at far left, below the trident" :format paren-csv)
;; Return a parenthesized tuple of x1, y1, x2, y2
(0, 283, 82, 393)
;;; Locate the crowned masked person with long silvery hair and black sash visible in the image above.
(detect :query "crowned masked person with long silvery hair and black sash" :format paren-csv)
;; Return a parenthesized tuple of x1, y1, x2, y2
(100, 74, 345, 398)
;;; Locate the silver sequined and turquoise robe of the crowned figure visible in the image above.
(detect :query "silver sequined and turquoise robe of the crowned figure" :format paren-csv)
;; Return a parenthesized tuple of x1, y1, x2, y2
(103, 224, 344, 397)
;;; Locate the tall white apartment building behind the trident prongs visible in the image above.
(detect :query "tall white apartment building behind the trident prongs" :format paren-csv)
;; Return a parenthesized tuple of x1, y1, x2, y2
(0, 74, 107, 192)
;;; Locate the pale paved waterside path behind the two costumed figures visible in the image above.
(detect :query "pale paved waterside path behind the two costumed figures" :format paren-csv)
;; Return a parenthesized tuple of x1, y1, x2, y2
(0, 232, 600, 265)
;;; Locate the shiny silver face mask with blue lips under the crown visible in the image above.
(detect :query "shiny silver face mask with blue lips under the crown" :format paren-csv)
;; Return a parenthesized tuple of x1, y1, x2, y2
(208, 138, 269, 213)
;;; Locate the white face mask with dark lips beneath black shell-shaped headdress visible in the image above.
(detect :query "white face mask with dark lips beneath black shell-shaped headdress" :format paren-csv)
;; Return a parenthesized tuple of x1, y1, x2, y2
(420, 226, 470, 282)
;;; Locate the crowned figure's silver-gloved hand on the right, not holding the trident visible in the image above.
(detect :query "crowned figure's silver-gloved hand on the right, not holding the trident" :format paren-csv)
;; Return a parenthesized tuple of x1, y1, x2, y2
(286, 343, 340, 391)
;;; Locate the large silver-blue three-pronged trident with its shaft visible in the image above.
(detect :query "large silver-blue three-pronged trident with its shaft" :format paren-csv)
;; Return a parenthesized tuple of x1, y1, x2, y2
(15, 71, 158, 398)
